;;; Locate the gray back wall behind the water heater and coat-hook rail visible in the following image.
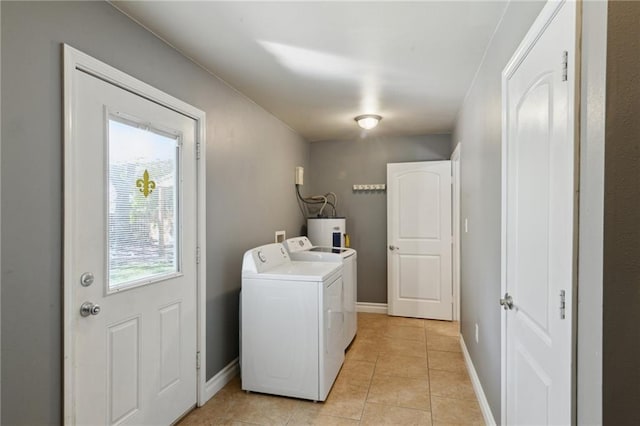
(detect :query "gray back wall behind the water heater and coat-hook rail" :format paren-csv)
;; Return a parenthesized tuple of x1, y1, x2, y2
(302, 131, 451, 303)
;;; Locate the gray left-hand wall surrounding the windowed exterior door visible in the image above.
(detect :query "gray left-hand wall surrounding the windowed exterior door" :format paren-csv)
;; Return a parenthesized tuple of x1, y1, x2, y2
(0, 1, 309, 424)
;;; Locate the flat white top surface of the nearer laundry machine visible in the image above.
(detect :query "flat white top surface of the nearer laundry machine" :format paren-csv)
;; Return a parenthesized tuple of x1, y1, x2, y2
(242, 262, 342, 282)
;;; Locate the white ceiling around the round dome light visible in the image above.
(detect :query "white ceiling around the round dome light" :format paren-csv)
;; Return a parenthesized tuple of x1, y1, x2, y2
(112, 0, 506, 141)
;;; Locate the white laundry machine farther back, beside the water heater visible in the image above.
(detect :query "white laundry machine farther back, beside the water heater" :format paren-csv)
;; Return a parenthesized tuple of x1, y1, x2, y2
(284, 237, 358, 349)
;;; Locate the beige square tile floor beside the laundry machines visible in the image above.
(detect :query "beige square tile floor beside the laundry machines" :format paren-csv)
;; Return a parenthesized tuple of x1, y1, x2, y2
(180, 313, 484, 426)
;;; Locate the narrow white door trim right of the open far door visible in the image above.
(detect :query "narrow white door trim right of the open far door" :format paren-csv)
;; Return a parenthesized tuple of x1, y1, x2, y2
(451, 142, 462, 321)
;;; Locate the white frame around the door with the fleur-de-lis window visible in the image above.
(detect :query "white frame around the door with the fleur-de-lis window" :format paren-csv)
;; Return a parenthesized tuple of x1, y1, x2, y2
(63, 44, 207, 424)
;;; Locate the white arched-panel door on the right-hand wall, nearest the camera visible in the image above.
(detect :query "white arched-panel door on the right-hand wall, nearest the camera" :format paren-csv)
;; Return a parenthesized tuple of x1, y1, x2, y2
(501, 2, 576, 425)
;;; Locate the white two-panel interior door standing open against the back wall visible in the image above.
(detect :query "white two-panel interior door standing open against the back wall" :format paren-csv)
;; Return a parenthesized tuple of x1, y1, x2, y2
(387, 161, 452, 320)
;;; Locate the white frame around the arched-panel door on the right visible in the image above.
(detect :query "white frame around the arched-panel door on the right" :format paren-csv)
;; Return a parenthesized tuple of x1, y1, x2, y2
(496, 0, 582, 424)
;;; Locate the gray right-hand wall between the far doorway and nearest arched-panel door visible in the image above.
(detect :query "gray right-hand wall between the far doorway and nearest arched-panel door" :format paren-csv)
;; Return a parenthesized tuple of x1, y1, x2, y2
(452, 2, 544, 421)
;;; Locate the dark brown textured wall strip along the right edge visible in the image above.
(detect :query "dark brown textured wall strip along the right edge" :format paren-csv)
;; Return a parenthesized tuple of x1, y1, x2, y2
(603, 1, 640, 425)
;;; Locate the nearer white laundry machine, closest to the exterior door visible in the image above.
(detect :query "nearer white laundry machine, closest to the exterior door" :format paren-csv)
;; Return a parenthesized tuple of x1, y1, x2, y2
(240, 243, 344, 401)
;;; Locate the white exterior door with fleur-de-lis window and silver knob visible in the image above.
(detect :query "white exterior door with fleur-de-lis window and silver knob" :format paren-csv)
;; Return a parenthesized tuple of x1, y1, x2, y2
(65, 59, 198, 425)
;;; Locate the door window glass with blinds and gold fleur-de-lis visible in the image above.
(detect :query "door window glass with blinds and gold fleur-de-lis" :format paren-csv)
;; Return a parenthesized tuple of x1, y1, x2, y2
(107, 116, 180, 291)
